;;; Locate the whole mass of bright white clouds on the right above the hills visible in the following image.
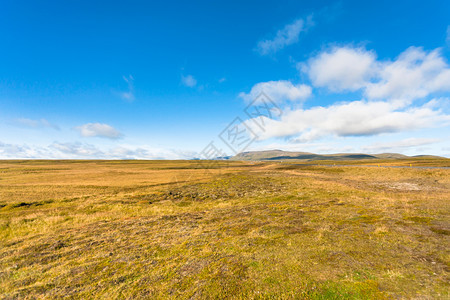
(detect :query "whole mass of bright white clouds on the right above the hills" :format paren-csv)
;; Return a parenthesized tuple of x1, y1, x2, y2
(240, 46, 450, 147)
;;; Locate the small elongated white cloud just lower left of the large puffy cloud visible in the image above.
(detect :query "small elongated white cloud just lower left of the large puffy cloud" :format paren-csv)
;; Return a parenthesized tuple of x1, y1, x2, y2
(239, 80, 312, 103)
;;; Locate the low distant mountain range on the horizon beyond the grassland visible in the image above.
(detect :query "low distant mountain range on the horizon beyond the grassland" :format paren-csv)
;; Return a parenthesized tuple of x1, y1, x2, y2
(229, 150, 441, 160)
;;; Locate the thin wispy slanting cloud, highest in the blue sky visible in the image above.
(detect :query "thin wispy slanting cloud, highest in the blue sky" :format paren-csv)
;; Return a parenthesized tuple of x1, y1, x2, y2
(256, 17, 311, 55)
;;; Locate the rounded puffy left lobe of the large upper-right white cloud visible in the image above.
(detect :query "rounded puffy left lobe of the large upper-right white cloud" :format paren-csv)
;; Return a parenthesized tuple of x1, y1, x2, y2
(298, 47, 376, 91)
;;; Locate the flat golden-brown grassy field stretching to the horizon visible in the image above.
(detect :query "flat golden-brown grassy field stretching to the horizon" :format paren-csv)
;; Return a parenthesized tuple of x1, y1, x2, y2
(0, 158, 450, 299)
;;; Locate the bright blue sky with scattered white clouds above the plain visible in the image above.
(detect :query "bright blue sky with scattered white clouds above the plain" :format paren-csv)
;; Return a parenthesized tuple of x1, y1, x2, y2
(0, 0, 450, 159)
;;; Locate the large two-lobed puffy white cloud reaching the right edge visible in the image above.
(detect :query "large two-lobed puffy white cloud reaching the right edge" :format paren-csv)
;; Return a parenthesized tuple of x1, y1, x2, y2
(299, 46, 450, 102)
